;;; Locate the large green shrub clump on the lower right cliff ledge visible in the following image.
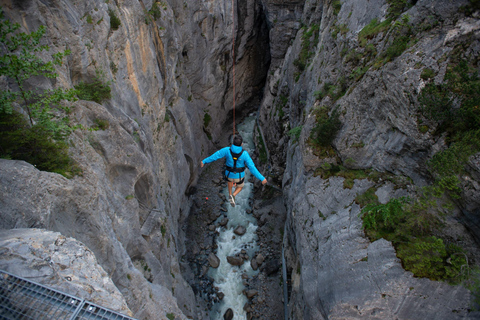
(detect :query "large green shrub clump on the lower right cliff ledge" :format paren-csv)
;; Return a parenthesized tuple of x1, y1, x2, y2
(360, 198, 468, 284)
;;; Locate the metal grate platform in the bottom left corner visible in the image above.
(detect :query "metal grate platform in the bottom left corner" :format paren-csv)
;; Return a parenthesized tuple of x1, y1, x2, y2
(0, 270, 135, 320)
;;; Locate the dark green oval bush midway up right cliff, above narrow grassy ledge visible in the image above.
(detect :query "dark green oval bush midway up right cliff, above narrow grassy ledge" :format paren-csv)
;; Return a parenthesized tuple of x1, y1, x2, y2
(310, 107, 342, 147)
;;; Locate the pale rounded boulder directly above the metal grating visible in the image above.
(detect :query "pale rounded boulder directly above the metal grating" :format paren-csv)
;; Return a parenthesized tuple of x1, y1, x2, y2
(0, 229, 132, 316)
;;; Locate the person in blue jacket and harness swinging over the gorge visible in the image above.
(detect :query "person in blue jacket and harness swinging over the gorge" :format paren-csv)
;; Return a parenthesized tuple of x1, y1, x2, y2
(200, 134, 267, 207)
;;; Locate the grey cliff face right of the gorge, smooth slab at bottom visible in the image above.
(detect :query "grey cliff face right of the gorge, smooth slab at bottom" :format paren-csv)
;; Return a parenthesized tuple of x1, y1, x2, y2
(259, 0, 480, 319)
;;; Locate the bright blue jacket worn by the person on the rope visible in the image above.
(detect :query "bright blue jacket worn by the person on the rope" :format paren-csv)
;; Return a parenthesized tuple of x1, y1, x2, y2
(202, 145, 265, 181)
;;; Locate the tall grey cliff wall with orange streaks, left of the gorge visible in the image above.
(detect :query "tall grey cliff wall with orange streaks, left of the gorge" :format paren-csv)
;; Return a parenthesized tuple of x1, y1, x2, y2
(0, 0, 270, 319)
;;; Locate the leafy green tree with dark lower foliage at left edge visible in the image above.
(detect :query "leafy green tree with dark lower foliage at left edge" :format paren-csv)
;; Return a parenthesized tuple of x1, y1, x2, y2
(0, 9, 76, 175)
